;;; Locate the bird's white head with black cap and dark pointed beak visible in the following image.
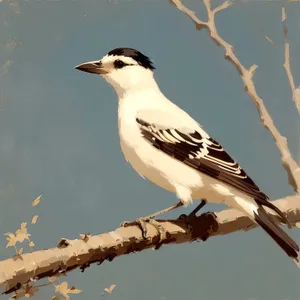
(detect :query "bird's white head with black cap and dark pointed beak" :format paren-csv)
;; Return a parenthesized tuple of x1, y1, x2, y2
(75, 48, 155, 95)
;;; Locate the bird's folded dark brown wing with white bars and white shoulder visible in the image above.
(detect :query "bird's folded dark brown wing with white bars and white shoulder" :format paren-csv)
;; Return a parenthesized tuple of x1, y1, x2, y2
(136, 110, 269, 206)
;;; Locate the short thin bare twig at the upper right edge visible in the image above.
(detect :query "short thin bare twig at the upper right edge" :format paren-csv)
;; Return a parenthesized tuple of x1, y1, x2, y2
(281, 7, 300, 113)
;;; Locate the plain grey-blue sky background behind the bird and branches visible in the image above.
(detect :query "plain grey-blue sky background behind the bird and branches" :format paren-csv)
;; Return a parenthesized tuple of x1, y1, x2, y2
(0, 0, 300, 300)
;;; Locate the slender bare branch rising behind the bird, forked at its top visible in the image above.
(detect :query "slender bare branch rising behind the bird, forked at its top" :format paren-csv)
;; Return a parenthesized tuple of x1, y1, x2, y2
(170, 0, 300, 193)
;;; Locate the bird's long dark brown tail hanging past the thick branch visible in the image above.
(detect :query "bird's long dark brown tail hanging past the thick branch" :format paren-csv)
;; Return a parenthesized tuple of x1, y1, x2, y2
(239, 201, 300, 267)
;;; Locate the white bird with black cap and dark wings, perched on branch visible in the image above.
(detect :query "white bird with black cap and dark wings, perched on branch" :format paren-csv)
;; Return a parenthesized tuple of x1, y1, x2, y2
(75, 48, 299, 267)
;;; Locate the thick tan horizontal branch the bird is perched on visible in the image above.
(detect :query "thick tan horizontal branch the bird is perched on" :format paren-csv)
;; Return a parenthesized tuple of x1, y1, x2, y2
(0, 196, 300, 294)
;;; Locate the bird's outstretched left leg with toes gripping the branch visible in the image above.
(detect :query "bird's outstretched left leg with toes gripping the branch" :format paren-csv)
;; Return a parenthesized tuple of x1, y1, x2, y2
(120, 201, 183, 240)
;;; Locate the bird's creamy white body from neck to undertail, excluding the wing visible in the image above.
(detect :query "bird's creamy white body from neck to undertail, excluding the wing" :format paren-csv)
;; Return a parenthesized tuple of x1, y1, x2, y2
(118, 89, 254, 209)
